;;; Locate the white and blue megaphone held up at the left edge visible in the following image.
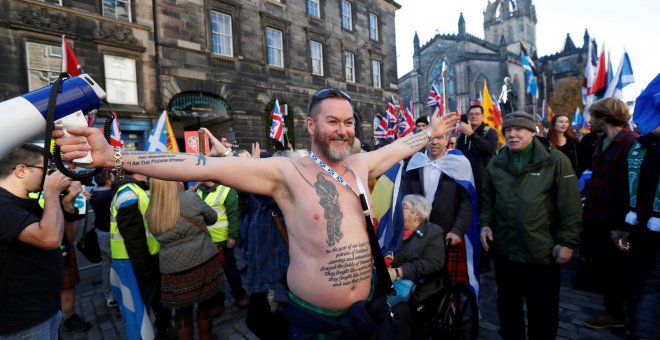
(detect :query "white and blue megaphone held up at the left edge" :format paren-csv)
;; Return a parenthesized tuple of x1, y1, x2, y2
(0, 74, 106, 164)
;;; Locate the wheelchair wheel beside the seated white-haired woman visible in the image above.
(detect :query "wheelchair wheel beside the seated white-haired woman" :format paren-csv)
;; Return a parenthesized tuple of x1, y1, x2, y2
(433, 283, 479, 340)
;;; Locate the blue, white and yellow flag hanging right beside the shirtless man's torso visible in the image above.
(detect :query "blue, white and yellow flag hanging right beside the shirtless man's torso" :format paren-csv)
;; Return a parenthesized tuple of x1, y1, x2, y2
(371, 161, 405, 255)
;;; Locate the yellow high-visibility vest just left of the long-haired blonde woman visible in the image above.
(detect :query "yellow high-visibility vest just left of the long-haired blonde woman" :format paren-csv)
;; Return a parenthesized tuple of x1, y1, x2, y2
(110, 183, 160, 260)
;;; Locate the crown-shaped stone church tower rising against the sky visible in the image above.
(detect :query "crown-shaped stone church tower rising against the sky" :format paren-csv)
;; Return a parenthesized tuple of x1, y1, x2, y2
(484, 0, 536, 54)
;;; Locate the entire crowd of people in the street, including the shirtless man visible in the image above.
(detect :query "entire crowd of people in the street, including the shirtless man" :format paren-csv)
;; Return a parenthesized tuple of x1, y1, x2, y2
(0, 88, 660, 339)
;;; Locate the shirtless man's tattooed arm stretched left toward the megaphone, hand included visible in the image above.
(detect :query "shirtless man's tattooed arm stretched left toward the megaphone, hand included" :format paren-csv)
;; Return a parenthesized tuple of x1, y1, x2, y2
(53, 128, 284, 196)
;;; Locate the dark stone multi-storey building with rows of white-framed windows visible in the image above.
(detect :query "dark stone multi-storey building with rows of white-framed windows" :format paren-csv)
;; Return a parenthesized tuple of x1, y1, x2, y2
(0, 0, 400, 149)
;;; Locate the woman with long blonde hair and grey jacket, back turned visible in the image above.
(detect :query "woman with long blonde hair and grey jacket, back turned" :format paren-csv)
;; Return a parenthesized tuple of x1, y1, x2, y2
(146, 179, 224, 339)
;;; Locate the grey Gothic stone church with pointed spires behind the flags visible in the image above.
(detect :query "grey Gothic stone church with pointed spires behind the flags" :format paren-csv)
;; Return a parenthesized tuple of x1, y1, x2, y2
(399, 0, 589, 118)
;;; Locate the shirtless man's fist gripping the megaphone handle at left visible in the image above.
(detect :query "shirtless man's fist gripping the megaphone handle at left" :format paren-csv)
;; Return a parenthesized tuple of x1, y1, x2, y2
(53, 127, 115, 168)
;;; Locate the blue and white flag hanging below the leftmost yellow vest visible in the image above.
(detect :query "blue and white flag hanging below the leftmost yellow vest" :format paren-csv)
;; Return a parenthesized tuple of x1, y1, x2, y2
(110, 259, 155, 340)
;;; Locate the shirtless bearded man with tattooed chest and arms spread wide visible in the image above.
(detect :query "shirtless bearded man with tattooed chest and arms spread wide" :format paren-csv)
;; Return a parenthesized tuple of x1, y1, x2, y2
(53, 89, 459, 338)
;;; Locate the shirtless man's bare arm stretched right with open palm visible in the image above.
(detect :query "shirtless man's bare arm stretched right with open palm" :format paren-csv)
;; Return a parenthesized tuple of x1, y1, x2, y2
(366, 109, 460, 178)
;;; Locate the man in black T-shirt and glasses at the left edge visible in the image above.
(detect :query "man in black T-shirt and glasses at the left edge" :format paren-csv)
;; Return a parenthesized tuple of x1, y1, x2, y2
(0, 144, 82, 339)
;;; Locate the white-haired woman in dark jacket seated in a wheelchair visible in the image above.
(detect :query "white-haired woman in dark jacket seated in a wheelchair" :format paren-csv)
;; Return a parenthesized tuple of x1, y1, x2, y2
(388, 195, 445, 339)
